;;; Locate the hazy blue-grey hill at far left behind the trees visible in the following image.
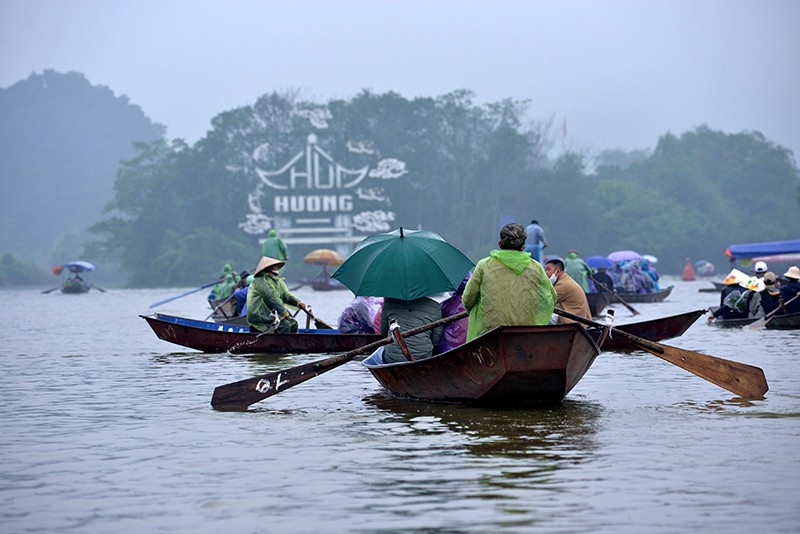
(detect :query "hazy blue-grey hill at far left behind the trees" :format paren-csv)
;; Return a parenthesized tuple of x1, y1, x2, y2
(0, 70, 165, 264)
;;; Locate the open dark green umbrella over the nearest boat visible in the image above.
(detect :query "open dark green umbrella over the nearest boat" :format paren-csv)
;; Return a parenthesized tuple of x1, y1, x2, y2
(333, 228, 474, 300)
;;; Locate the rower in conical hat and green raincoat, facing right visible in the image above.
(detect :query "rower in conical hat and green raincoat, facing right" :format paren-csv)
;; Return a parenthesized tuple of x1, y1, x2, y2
(247, 256, 306, 333)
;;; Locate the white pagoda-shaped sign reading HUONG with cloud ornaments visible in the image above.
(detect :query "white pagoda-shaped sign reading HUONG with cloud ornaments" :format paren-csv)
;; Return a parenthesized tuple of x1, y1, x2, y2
(239, 121, 408, 246)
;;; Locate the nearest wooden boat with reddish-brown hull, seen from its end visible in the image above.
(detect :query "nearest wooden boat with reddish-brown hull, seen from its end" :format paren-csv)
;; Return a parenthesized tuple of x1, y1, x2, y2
(362, 324, 600, 405)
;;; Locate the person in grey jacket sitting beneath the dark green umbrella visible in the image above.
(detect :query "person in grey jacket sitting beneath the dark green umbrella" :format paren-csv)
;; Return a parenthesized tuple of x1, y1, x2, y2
(381, 297, 443, 363)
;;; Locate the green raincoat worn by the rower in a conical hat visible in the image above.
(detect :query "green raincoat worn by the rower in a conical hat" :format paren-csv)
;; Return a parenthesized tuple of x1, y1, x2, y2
(247, 271, 301, 333)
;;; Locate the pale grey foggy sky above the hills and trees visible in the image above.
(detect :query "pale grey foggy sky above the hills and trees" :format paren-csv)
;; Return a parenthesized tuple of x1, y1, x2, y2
(0, 0, 800, 159)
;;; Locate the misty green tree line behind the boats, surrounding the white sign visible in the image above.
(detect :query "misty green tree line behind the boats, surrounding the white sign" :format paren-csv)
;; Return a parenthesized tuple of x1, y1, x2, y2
(87, 91, 800, 286)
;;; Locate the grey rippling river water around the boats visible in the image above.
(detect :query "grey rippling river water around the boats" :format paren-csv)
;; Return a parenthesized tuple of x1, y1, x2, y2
(0, 279, 800, 533)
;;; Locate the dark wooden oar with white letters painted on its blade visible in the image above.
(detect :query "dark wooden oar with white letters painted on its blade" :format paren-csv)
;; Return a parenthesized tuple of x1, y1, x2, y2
(211, 311, 468, 410)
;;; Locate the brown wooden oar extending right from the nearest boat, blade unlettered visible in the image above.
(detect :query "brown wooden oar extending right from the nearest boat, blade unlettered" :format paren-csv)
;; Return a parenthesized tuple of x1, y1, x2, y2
(555, 308, 769, 399)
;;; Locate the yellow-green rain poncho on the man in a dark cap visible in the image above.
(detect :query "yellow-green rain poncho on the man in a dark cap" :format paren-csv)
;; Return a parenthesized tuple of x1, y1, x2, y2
(461, 250, 556, 341)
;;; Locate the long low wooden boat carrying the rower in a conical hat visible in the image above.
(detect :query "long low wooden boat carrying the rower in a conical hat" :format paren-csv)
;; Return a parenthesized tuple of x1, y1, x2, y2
(139, 313, 382, 354)
